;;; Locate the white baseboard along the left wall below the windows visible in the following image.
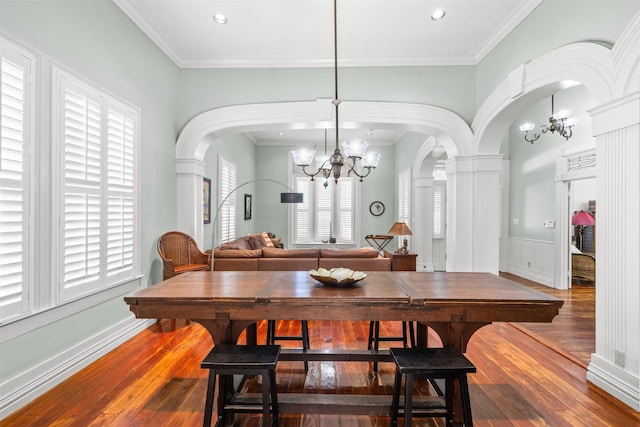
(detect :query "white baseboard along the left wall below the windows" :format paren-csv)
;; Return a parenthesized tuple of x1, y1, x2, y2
(0, 317, 153, 420)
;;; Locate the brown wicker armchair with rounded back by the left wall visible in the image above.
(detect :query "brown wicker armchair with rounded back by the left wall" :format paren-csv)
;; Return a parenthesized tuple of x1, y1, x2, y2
(158, 231, 211, 280)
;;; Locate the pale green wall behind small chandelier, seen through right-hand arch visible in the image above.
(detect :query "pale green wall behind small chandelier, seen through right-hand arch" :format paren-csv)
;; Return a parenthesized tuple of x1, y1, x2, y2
(508, 86, 595, 242)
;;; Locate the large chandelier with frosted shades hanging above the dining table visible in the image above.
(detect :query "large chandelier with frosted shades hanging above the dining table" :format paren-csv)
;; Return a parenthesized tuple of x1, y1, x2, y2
(291, 0, 380, 187)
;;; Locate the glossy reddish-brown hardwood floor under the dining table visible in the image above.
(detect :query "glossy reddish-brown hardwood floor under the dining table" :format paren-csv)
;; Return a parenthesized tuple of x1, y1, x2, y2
(0, 275, 640, 427)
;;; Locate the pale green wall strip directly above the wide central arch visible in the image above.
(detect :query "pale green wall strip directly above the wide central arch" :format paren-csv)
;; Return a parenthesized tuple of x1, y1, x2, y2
(178, 66, 475, 127)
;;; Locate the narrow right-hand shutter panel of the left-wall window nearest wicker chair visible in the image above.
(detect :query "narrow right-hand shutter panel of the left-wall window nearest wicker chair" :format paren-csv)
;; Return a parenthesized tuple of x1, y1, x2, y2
(107, 109, 135, 276)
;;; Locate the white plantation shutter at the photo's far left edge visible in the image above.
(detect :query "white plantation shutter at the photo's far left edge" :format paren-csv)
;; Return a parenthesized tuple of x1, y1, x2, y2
(0, 48, 32, 319)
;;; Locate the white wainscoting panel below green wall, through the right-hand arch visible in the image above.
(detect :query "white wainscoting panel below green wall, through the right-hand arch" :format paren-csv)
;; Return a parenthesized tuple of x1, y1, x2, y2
(507, 237, 555, 288)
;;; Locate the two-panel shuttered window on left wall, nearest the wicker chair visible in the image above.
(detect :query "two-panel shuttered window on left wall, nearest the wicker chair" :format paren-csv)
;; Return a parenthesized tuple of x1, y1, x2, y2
(53, 68, 138, 301)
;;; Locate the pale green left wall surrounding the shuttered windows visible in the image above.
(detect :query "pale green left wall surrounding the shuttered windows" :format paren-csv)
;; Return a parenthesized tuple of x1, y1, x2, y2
(0, 0, 179, 383)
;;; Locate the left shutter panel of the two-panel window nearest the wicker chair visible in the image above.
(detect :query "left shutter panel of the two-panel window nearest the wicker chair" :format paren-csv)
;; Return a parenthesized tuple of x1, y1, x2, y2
(62, 81, 102, 296)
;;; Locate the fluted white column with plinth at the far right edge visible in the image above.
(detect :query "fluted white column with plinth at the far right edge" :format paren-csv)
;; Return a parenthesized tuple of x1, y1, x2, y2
(587, 92, 640, 410)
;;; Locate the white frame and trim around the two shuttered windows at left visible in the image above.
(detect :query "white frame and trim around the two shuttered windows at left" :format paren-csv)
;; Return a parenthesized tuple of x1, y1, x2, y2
(0, 31, 142, 342)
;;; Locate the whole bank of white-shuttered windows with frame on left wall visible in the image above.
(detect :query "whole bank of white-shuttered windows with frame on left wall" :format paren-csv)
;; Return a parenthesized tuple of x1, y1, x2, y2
(0, 35, 140, 328)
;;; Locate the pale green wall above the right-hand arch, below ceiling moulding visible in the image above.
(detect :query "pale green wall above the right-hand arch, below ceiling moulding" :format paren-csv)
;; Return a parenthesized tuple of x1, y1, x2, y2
(476, 0, 640, 110)
